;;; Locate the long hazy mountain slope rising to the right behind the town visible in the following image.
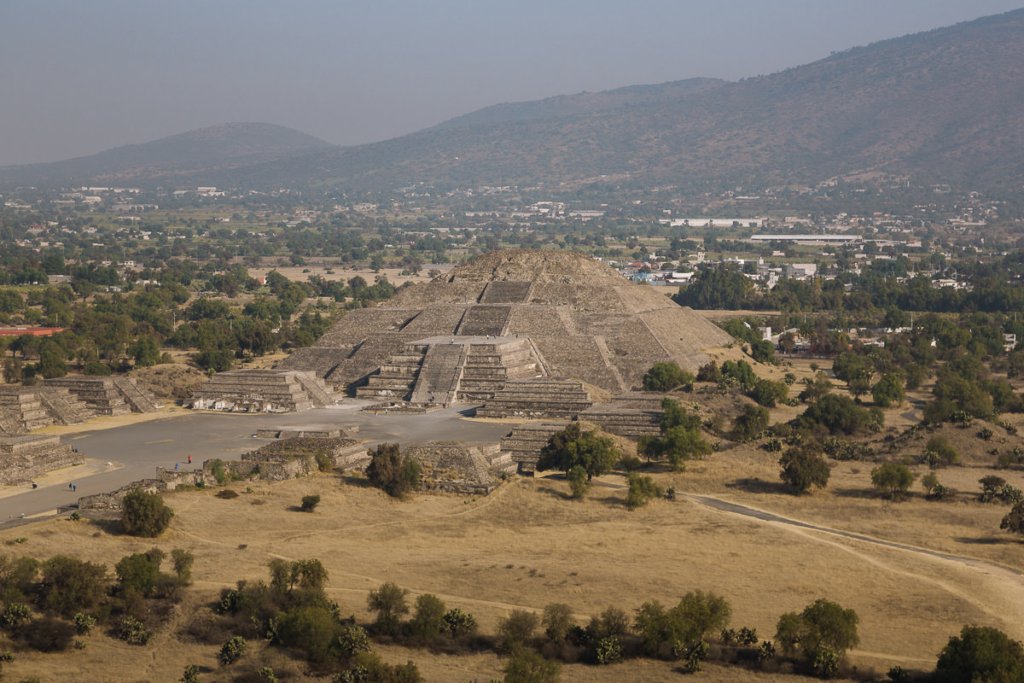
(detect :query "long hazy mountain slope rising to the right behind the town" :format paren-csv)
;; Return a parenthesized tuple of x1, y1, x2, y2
(0, 10, 1024, 193)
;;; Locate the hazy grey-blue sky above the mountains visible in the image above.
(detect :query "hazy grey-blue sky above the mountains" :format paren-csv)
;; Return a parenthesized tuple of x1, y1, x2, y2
(0, 0, 1024, 165)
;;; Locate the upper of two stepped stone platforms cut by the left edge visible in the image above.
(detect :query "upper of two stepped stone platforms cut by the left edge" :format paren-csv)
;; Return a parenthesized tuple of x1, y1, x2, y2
(0, 385, 95, 435)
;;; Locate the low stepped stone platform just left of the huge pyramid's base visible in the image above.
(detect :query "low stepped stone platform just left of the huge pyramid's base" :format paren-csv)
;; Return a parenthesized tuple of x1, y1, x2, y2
(185, 370, 340, 413)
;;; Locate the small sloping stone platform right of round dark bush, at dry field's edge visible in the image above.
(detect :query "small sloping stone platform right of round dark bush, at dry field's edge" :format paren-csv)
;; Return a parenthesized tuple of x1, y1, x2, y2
(401, 441, 515, 496)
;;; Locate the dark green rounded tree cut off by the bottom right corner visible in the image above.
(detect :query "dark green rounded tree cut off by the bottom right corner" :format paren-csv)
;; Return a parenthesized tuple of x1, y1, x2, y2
(935, 626, 1024, 683)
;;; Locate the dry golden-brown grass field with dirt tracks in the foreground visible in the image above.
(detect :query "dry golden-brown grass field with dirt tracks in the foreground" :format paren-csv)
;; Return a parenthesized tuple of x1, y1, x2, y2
(0, 440, 1024, 681)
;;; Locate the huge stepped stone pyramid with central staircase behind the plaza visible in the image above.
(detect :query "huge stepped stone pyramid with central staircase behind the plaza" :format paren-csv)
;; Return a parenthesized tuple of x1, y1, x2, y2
(280, 250, 733, 404)
